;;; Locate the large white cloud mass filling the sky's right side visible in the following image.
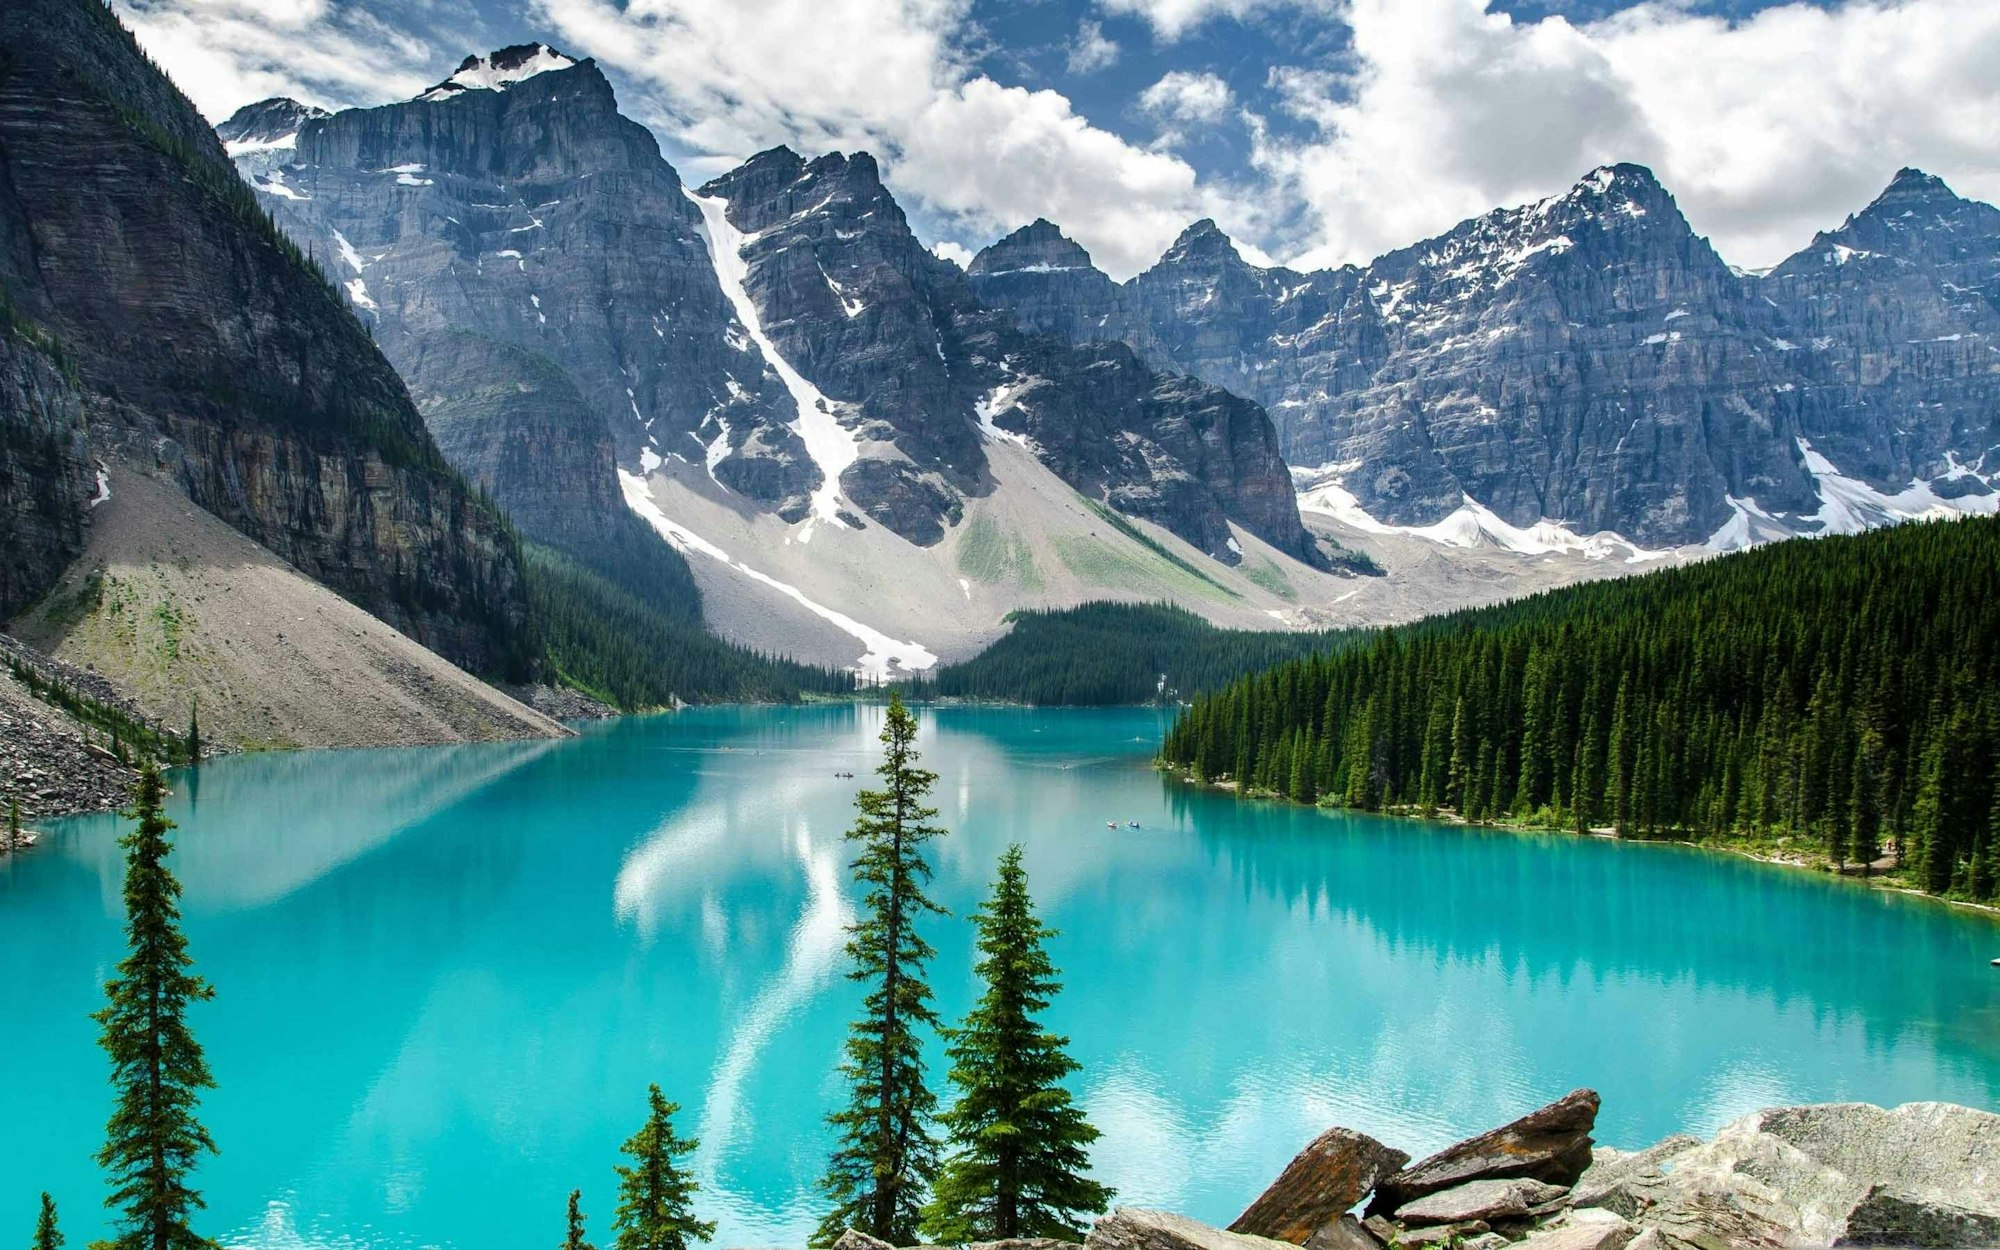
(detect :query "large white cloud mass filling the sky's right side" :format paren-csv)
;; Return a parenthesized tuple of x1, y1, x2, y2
(1256, 0, 2000, 266)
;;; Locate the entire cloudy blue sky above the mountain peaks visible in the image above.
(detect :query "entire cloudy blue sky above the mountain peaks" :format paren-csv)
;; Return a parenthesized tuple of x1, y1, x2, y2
(114, 0, 2000, 278)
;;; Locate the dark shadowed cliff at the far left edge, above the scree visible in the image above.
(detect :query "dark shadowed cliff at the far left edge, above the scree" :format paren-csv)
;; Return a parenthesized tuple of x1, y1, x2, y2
(0, 0, 534, 674)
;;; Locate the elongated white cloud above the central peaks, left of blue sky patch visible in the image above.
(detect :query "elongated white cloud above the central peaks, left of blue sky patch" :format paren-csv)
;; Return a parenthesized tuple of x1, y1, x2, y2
(536, 0, 1214, 276)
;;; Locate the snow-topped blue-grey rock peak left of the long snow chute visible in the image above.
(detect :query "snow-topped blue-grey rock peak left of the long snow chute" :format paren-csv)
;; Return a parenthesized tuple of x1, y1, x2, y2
(220, 53, 764, 616)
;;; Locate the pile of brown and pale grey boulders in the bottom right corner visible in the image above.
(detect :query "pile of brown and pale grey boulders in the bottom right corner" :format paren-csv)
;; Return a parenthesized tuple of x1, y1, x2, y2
(1208, 1090, 2000, 1250)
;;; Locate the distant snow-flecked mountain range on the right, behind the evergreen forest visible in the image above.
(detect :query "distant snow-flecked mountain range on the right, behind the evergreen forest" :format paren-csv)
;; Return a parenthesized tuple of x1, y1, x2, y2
(968, 164, 2000, 556)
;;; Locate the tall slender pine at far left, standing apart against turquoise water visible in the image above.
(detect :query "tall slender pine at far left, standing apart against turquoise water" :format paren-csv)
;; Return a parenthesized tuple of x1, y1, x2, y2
(94, 760, 216, 1250)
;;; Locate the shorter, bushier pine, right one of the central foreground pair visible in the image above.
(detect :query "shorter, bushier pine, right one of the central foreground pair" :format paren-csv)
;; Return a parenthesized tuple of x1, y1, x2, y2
(924, 844, 1112, 1244)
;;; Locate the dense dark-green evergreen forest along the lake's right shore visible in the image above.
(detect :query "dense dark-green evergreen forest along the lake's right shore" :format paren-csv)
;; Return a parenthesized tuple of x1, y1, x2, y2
(1160, 518, 2000, 900)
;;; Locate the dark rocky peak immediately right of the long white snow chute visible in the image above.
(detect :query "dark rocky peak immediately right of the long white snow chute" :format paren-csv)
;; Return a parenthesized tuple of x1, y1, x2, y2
(702, 148, 1310, 562)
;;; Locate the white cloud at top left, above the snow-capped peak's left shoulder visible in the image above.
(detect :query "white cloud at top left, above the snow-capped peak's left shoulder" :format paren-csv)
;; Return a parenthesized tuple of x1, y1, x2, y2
(118, 0, 454, 122)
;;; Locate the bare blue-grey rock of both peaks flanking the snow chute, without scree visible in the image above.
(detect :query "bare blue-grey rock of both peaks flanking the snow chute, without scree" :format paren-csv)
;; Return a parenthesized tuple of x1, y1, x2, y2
(222, 74, 1310, 580)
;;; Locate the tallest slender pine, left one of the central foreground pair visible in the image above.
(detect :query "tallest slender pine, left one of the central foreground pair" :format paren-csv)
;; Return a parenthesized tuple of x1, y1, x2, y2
(814, 694, 944, 1246)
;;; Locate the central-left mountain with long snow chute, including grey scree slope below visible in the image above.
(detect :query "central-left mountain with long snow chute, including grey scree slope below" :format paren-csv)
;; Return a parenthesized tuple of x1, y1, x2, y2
(218, 44, 1340, 670)
